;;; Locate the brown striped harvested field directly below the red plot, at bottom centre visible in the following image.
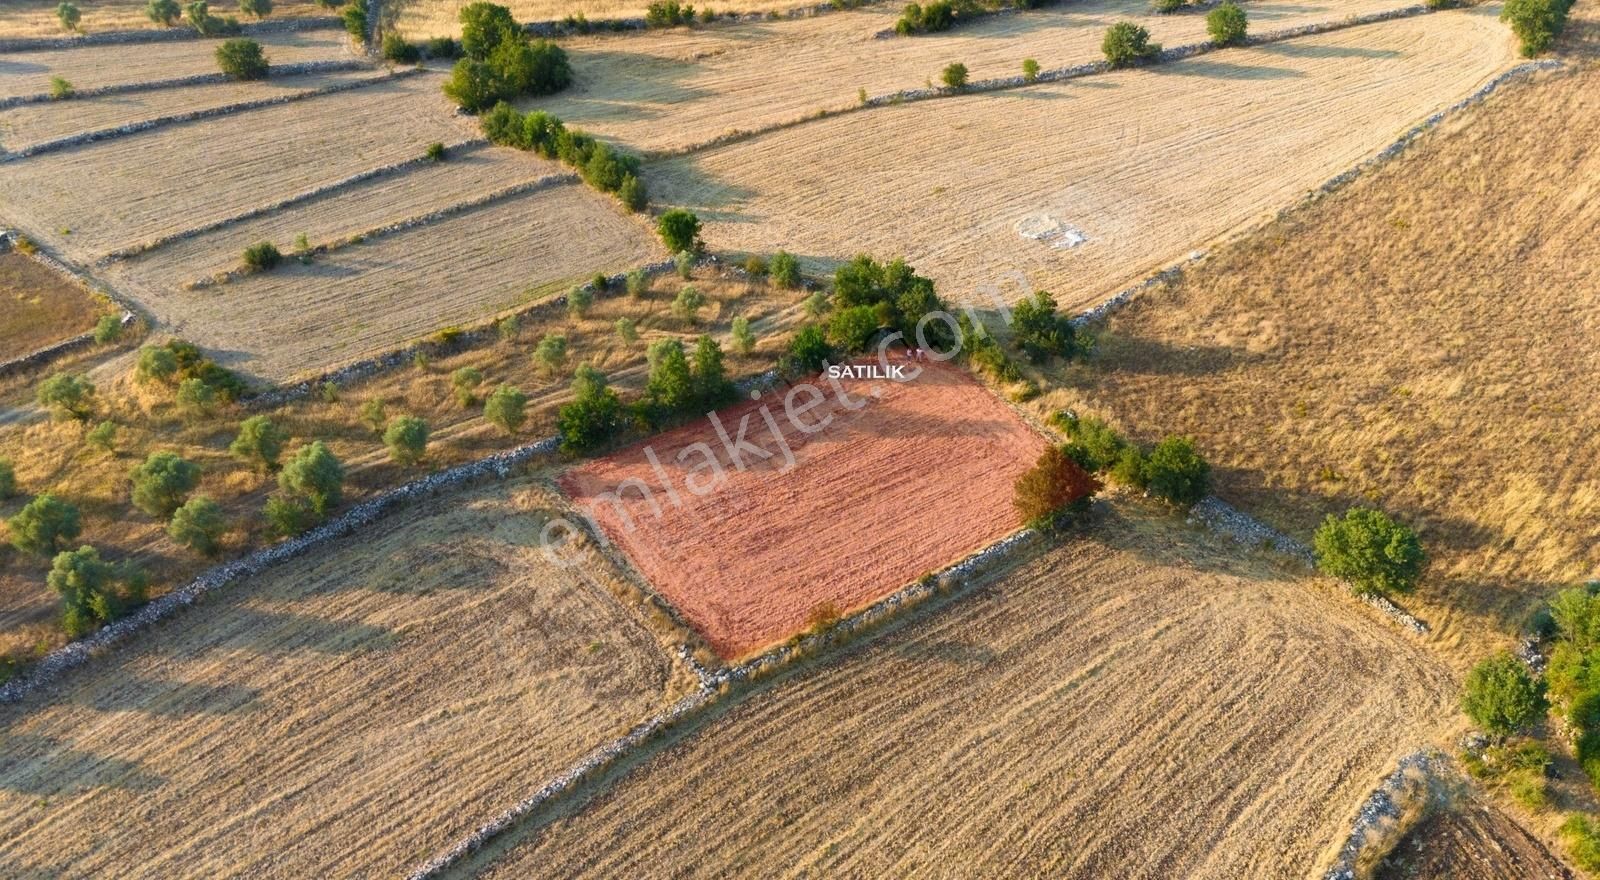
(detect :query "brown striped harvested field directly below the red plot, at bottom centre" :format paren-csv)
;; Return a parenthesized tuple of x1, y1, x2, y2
(462, 504, 1454, 880)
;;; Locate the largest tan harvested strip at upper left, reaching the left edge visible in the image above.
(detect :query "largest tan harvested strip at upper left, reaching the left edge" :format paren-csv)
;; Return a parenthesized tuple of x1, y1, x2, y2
(0, 74, 477, 262)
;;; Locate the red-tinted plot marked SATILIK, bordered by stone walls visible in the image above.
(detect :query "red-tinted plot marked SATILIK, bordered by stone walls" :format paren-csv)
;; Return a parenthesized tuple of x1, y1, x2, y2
(560, 362, 1045, 659)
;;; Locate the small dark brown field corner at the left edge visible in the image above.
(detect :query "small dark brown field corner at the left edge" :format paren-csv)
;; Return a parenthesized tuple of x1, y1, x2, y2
(0, 251, 107, 362)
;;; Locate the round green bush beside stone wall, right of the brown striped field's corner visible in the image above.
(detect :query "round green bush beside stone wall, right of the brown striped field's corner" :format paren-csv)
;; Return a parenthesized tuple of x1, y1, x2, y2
(1312, 507, 1427, 594)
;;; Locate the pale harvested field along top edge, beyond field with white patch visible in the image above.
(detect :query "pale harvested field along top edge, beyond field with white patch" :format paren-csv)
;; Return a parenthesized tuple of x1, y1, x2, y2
(525, 0, 1398, 153)
